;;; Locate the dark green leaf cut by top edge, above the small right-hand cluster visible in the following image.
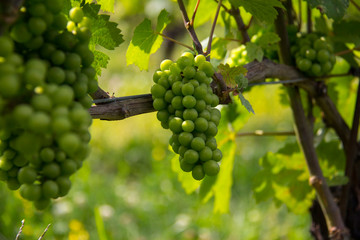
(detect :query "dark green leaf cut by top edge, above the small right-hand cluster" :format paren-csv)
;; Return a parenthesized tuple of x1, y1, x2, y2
(306, 0, 349, 21)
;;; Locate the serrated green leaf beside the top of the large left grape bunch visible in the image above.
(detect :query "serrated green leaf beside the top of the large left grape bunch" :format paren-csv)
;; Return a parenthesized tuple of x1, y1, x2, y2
(83, 4, 124, 75)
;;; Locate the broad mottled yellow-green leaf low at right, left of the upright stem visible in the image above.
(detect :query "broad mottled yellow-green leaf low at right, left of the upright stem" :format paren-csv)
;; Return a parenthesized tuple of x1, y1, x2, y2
(253, 152, 315, 214)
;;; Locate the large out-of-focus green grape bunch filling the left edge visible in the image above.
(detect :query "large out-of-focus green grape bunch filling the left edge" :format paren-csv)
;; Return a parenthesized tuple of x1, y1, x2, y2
(0, 0, 98, 209)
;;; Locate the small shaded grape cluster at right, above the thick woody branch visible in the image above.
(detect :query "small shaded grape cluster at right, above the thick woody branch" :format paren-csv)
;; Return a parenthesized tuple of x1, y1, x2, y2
(291, 33, 335, 77)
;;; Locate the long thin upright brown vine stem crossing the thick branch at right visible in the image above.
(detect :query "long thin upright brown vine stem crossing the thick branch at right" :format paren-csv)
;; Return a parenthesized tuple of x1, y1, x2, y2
(275, 5, 348, 240)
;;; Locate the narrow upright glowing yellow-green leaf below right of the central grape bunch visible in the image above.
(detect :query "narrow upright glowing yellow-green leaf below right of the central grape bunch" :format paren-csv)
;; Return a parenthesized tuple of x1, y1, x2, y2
(213, 141, 236, 213)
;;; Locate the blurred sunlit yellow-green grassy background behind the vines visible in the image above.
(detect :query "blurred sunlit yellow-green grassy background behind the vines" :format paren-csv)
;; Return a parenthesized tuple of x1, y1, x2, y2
(0, 0, 311, 240)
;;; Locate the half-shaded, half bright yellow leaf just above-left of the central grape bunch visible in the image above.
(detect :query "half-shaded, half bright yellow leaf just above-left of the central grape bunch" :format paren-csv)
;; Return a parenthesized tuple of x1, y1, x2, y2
(126, 9, 170, 70)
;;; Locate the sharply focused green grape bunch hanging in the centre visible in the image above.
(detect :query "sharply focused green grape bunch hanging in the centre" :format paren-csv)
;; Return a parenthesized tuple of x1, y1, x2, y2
(151, 52, 222, 180)
